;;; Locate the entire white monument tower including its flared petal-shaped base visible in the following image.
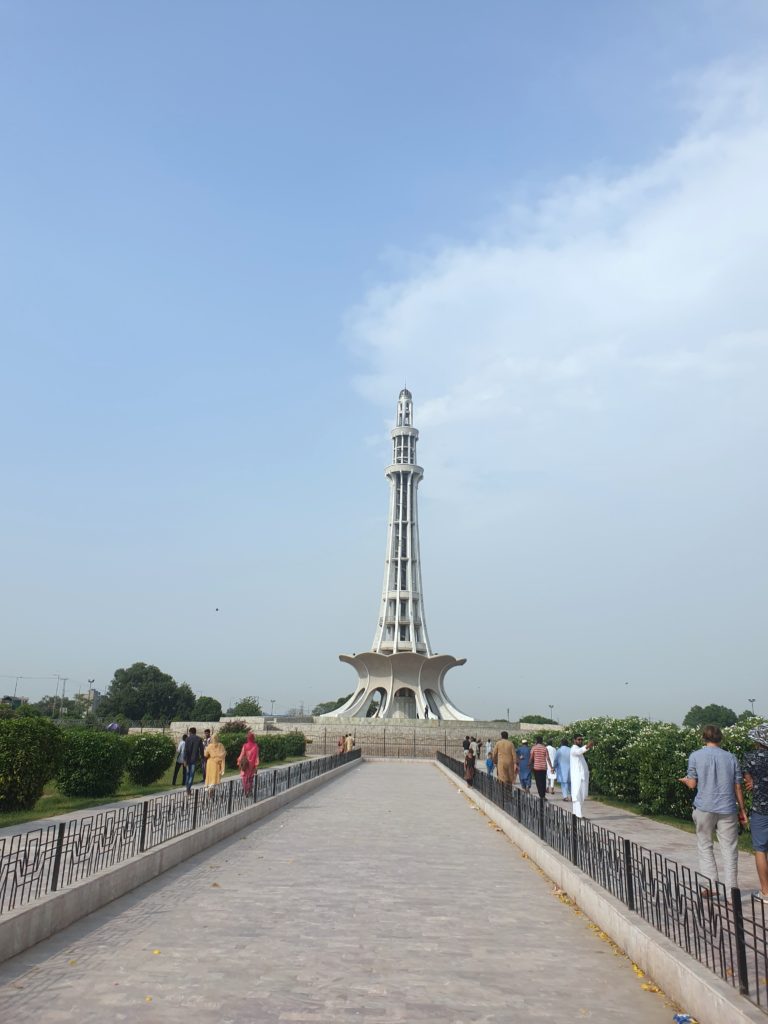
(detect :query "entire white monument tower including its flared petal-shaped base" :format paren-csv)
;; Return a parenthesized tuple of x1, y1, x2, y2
(325, 388, 472, 722)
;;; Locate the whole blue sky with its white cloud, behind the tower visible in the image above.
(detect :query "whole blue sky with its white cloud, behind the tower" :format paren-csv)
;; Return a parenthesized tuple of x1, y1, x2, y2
(0, 0, 768, 718)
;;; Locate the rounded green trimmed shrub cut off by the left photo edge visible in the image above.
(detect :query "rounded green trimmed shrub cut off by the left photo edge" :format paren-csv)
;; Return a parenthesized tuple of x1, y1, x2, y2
(0, 717, 63, 811)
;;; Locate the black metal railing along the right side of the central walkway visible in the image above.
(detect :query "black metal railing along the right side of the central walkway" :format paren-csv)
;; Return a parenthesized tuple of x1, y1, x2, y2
(436, 752, 768, 1013)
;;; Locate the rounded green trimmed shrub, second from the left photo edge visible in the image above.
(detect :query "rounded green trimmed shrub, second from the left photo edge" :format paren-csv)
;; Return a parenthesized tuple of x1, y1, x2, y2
(57, 729, 128, 797)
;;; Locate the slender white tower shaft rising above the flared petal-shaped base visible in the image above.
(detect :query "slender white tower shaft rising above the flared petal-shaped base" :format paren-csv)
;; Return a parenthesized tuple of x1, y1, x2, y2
(371, 388, 432, 657)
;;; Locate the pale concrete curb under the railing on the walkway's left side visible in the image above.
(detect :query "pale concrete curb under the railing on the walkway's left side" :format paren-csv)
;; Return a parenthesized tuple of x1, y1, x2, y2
(0, 759, 360, 963)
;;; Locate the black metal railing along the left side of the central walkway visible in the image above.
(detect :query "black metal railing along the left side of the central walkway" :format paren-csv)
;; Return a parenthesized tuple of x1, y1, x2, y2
(0, 750, 360, 914)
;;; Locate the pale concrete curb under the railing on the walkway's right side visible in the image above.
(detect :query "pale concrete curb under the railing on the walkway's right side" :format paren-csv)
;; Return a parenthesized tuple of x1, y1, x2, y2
(436, 763, 768, 1024)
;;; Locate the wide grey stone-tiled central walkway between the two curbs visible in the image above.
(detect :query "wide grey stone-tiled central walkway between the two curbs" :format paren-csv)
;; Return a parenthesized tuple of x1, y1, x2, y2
(0, 762, 674, 1024)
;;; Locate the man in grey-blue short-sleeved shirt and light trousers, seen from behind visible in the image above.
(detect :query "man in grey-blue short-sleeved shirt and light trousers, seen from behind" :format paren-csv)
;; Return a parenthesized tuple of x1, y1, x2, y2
(680, 725, 746, 889)
